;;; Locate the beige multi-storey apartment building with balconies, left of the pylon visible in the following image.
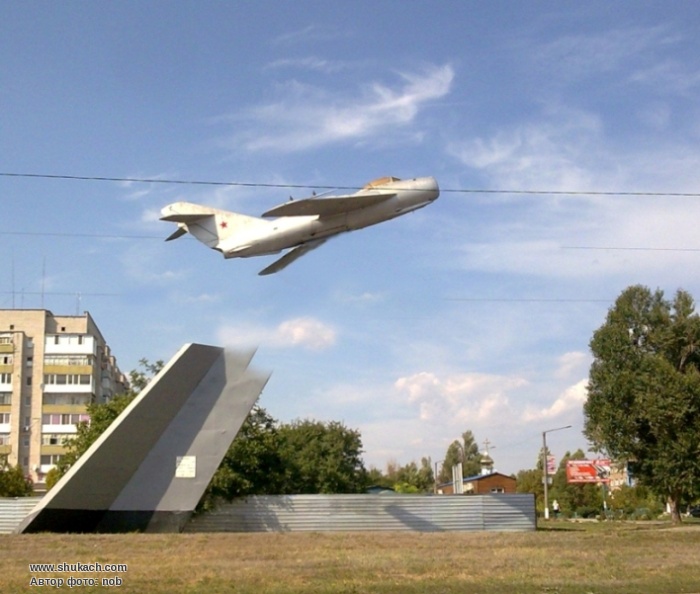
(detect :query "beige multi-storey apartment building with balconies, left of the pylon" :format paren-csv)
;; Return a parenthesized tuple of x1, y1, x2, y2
(0, 309, 128, 490)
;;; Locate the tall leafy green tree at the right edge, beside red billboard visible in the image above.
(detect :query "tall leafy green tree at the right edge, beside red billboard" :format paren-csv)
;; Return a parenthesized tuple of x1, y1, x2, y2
(584, 286, 700, 522)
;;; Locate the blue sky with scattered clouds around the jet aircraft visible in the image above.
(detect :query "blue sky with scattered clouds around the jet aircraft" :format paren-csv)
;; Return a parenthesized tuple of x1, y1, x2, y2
(0, 0, 700, 473)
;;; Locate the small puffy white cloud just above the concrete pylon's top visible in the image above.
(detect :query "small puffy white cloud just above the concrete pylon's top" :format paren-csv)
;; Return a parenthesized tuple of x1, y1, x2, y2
(218, 317, 337, 350)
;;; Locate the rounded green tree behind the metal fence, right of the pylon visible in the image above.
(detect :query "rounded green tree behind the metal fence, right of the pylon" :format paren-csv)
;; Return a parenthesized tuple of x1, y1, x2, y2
(279, 419, 367, 493)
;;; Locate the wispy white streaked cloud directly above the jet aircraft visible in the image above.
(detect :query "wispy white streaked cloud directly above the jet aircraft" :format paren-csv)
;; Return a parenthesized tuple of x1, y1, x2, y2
(224, 65, 454, 152)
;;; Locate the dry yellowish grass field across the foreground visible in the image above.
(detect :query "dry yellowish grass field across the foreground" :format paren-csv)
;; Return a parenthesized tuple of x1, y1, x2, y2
(0, 522, 700, 594)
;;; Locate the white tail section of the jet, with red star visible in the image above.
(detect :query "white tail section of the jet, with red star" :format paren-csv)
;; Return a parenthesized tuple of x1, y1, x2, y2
(160, 202, 269, 249)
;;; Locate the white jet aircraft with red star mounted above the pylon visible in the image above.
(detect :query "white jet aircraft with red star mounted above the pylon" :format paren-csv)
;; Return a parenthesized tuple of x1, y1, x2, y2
(161, 177, 440, 275)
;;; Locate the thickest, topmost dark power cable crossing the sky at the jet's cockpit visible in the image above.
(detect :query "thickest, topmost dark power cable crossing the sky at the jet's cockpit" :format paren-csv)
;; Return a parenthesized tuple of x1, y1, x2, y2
(0, 172, 700, 198)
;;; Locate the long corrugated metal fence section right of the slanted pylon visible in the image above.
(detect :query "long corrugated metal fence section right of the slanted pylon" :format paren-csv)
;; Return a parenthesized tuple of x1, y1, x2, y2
(185, 494, 537, 532)
